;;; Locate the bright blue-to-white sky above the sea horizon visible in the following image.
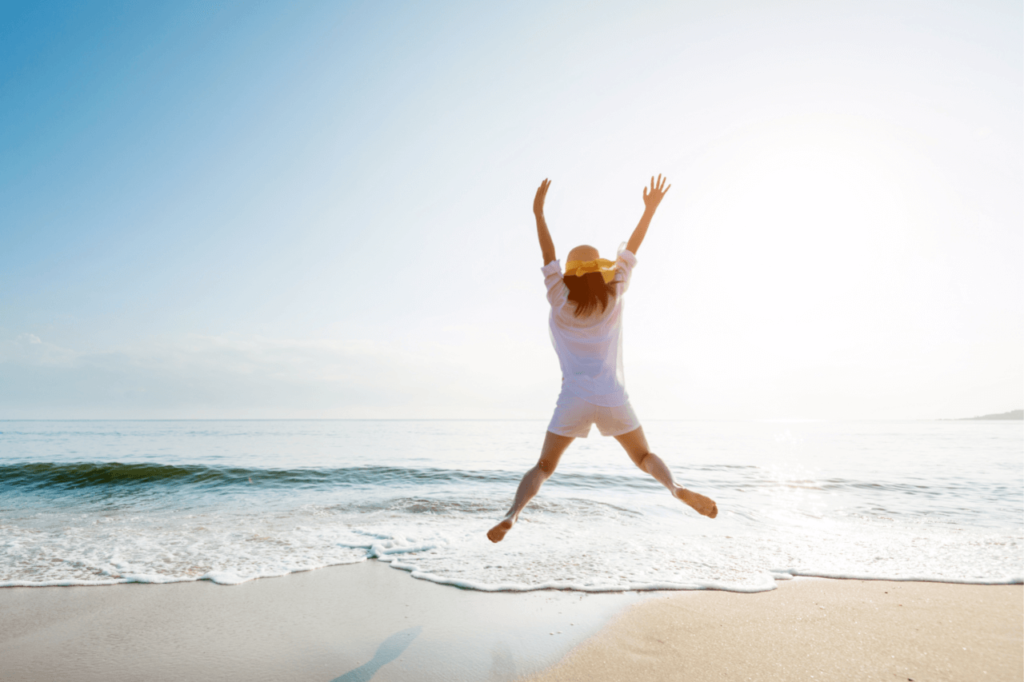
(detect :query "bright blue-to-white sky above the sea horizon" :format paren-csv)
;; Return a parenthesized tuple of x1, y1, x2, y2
(0, 0, 1024, 420)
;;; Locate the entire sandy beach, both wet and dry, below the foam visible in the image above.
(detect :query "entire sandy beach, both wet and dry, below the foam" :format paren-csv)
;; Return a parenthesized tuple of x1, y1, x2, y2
(0, 561, 1024, 682)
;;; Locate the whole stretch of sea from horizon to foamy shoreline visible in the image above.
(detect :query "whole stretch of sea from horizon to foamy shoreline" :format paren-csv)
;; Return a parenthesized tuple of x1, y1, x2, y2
(0, 421, 1024, 591)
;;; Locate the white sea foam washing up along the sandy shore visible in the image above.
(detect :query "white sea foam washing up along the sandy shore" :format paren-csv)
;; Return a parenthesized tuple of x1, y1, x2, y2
(0, 509, 1021, 592)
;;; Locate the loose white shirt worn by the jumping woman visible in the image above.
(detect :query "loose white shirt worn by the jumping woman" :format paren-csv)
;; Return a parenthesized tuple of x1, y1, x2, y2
(541, 249, 637, 408)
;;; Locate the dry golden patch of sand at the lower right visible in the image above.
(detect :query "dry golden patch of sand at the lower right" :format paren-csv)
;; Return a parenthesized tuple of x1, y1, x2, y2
(530, 579, 1024, 682)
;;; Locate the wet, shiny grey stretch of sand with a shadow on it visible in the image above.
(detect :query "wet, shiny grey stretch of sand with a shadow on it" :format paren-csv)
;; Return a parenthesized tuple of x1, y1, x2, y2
(0, 561, 644, 682)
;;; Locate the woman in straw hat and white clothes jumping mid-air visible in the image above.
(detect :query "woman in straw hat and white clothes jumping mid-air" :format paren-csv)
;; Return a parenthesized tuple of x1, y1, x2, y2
(487, 175, 718, 543)
